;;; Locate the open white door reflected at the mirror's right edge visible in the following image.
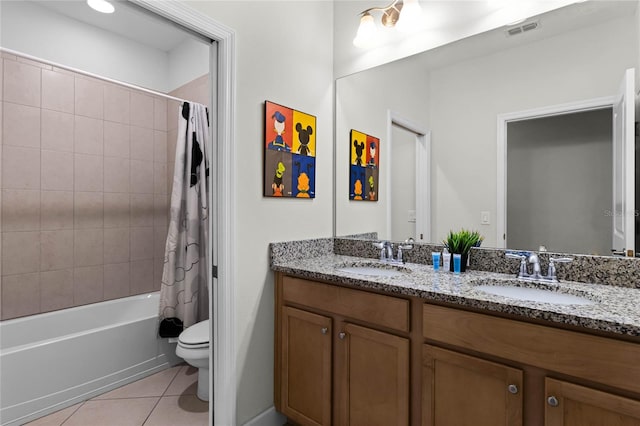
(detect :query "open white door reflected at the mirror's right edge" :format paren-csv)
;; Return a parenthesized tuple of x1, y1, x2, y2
(611, 68, 635, 256)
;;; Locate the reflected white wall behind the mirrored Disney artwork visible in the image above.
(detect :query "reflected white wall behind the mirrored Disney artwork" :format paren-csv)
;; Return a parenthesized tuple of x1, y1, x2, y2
(336, 52, 429, 238)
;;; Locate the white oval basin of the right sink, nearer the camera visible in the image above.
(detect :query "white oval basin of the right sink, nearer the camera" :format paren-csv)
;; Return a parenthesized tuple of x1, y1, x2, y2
(475, 283, 597, 305)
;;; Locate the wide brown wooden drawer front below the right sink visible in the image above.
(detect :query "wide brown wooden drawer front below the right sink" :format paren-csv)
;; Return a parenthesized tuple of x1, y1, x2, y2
(422, 304, 640, 392)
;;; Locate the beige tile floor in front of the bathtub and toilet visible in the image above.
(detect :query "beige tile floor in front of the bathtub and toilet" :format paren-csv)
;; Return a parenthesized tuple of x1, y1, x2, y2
(27, 364, 209, 426)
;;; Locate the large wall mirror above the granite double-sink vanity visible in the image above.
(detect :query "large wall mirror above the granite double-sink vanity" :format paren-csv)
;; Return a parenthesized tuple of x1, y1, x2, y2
(335, 1, 640, 255)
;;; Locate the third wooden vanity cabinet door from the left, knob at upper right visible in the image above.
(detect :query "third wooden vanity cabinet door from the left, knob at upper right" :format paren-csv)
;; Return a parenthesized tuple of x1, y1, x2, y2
(422, 345, 523, 426)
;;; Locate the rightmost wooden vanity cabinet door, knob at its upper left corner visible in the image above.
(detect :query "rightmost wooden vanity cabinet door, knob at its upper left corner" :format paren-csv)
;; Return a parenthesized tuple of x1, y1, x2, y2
(545, 378, 640, 426)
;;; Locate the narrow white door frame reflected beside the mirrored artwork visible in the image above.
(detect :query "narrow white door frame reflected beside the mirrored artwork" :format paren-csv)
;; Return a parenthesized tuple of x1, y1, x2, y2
(386, 110, 431, 242)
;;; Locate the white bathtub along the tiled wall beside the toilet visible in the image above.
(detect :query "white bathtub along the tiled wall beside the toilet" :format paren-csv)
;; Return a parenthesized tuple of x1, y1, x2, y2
(0, 292, 180, 426)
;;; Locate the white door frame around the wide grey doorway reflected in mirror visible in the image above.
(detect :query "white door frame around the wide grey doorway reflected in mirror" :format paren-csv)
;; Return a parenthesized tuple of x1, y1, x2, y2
(496, 96, 616, 249)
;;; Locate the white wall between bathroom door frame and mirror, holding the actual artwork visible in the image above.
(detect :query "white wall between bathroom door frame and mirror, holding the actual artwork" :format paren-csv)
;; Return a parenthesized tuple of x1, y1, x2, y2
(189, 1, 333, 424)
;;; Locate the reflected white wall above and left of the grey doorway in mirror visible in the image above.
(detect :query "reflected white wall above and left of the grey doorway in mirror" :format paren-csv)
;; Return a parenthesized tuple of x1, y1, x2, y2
(429, 17, 637, 247)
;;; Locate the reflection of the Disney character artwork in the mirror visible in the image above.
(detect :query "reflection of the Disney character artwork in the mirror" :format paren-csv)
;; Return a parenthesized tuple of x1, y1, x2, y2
(349, 129, 380, 201)
